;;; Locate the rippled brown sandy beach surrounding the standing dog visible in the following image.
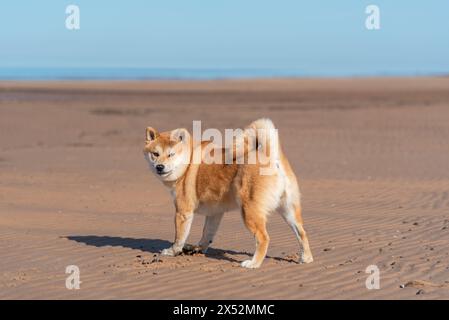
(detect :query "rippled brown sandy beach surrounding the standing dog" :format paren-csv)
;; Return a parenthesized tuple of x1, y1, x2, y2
(0, 77, 449, 299)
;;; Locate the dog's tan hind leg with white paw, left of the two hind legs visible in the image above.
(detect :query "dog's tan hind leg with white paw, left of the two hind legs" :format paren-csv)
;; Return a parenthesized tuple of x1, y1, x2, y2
(242, 203, 270, 268)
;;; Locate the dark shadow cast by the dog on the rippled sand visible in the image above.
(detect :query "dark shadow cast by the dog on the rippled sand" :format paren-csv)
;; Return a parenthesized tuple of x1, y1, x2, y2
(64, 235, 294, 263)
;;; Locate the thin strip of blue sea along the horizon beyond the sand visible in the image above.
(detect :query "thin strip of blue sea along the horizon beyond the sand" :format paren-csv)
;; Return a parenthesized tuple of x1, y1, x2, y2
(0, 68, 449, 80)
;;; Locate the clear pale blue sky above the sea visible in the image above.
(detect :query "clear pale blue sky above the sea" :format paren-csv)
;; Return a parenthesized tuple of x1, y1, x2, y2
(0, 0, 449, 74)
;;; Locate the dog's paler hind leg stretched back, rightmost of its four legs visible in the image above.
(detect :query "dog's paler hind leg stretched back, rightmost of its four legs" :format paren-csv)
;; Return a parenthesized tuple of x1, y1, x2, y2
(279, 200, 313, 263)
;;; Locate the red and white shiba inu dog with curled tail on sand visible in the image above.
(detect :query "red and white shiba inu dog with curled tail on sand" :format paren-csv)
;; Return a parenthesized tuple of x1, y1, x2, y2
(144, 119, 313, 268)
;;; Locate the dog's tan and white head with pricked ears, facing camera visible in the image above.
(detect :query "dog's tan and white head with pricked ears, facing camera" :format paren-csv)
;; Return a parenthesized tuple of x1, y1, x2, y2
(143, 127, 192, 182)
